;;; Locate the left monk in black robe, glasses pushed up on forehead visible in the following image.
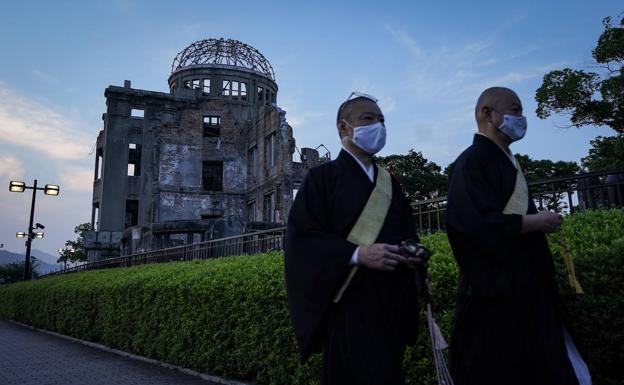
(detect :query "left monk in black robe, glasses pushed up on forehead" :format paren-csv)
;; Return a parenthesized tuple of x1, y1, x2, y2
(284, 93, 425, 385)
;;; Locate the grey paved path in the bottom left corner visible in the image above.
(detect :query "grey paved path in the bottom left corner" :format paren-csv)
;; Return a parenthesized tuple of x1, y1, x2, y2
(0, 321, 223, 385)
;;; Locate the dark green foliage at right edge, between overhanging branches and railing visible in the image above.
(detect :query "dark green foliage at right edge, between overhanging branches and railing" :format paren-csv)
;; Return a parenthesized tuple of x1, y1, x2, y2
(581, 134, 624, 171)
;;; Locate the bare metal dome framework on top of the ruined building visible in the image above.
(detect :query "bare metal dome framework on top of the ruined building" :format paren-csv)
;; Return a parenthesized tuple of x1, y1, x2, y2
(171, 38, 275, 81)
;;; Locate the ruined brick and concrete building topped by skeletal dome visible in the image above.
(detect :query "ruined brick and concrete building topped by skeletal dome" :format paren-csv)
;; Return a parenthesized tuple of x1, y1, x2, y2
(85, 39, 328, 261)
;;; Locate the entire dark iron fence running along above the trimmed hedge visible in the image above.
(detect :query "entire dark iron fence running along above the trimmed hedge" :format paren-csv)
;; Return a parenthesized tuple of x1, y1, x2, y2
(40, 168, 624, 277)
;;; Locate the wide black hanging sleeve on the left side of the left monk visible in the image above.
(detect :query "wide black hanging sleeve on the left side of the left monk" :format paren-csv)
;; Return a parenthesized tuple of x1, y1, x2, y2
(284, 169, 357, 360)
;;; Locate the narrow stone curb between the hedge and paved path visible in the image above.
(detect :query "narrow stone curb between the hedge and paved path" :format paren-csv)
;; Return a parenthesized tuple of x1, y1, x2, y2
(5, 319, 254, 385)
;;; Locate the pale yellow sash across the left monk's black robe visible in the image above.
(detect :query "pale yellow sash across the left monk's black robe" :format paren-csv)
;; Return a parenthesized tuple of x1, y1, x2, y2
(334, 166, 392, 303)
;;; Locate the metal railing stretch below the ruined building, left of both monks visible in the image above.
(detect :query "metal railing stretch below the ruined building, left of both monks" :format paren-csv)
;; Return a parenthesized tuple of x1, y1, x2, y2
(40, 227, 286, 278)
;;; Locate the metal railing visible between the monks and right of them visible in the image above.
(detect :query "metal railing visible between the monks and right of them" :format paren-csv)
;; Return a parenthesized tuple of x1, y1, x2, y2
(412, 168, 624, 232)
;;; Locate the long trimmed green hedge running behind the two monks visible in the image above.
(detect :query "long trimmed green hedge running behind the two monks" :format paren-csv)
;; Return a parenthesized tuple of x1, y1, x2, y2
(0, 209, 624, 385)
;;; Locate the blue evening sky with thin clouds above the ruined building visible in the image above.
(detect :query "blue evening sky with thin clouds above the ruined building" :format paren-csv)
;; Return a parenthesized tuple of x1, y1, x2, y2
(0, 0, 624, 253)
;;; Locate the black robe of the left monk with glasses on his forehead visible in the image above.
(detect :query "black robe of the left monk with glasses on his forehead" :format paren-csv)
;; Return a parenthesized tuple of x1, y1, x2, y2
(285, 150, 418, 385)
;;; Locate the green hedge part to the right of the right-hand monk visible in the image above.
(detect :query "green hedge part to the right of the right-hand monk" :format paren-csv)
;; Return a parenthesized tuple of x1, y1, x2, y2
(549, 209, 624, 385)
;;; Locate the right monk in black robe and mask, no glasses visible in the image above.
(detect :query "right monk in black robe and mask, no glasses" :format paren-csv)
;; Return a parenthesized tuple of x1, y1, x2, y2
(447, 87, 591, 385)
